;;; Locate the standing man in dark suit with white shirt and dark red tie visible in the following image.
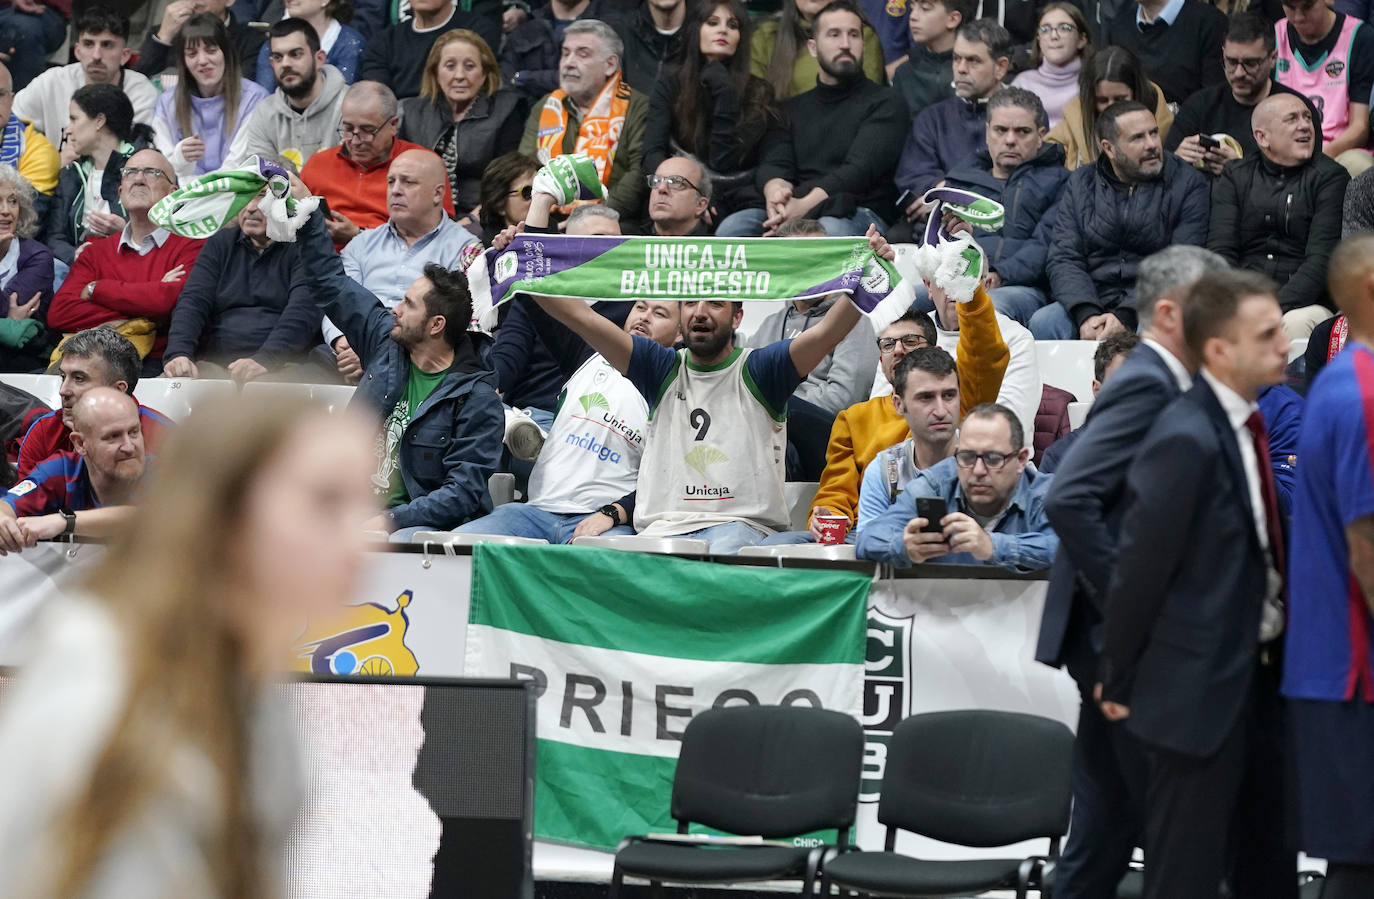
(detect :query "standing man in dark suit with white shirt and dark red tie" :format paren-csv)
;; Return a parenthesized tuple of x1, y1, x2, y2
(1099, 271, 1297, 899)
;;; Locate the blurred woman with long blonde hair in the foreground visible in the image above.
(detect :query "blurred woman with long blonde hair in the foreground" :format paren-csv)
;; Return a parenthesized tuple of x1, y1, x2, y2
(0, 396, 376, 899)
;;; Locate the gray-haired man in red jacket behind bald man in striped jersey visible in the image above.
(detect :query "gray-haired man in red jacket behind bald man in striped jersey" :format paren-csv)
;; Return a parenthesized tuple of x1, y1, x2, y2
(16, 327, 172, 480)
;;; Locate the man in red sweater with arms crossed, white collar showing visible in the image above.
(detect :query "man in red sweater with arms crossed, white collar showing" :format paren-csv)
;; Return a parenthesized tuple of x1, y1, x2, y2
(48, 150, 201, 374)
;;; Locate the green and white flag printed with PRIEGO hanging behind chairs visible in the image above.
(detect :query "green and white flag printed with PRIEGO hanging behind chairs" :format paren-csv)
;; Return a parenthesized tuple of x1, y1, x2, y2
(464, 544, 870, 850)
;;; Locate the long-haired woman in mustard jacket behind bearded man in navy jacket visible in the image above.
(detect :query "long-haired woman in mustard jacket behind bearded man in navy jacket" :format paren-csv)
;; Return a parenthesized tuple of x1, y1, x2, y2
(1046, 47, 1173, 172)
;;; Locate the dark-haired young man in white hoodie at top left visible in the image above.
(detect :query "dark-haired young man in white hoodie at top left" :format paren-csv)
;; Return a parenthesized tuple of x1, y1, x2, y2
(14, 7, 158, 149)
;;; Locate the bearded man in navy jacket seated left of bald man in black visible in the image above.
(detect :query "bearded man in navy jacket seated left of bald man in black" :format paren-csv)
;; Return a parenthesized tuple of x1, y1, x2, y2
(1031, 100, 1208, 340)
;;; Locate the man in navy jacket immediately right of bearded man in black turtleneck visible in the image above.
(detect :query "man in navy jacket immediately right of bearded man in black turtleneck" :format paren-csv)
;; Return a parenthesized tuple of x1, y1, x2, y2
(896, 19, 1011, 221)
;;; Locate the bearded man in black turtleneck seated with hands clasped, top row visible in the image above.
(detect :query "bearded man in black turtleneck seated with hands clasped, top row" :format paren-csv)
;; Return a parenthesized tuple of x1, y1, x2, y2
(716, 0, 907, 236)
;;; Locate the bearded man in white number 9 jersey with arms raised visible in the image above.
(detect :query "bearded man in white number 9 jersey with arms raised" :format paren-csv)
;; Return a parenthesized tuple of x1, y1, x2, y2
(536, 221, 894, 554)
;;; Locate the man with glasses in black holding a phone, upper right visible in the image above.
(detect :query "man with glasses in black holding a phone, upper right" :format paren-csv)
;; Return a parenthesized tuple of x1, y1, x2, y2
(1164, 12, 1322, 176)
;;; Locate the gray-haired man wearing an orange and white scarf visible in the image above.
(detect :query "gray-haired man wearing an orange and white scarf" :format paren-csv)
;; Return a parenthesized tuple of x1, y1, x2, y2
(519, 19, 649, 216)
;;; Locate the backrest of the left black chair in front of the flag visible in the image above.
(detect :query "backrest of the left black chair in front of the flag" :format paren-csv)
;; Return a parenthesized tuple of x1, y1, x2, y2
(672, 705, 863, 839)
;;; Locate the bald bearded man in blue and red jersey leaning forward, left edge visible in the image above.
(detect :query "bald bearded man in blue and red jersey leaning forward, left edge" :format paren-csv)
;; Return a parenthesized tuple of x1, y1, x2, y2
(0, 388, 147, 555)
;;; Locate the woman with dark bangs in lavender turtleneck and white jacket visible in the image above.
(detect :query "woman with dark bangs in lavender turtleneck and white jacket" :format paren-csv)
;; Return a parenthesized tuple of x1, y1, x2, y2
(153, 12, 267, 177)
